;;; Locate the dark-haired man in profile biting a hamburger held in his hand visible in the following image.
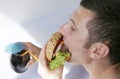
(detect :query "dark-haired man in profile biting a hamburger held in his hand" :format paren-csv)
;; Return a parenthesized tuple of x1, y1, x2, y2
(25, 0, 120, 79)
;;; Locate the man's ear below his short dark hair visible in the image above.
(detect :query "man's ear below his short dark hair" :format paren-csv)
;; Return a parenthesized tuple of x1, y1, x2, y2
(90, 43, 109, 59)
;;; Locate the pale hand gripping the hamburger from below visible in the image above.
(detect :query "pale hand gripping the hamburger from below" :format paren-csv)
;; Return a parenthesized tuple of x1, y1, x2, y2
(38, 45, 63, 79)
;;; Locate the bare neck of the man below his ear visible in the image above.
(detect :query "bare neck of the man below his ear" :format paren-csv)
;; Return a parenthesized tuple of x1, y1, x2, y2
(84, 60, 118, 79)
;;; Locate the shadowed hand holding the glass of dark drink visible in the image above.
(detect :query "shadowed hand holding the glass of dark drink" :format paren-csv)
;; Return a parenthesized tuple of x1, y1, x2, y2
(23, 42, 41, 68)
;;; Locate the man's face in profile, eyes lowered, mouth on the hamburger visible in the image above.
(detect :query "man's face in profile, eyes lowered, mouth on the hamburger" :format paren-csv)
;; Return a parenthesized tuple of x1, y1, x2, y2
(59, 7, 93, 64)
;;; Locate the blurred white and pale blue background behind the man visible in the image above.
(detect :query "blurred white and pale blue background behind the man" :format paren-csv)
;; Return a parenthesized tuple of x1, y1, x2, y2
(0, 0, 88, 79)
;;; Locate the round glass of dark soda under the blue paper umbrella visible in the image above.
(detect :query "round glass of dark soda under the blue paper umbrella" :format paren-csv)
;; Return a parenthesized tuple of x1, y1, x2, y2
(10, 50, 30, 73)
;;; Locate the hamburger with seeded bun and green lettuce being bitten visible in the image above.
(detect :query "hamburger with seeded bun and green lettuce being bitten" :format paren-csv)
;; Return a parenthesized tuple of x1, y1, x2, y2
(46, 32, 71, 70)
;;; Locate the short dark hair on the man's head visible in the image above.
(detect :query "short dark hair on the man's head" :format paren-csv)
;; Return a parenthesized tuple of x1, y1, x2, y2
(80, 0, 120, 64)
